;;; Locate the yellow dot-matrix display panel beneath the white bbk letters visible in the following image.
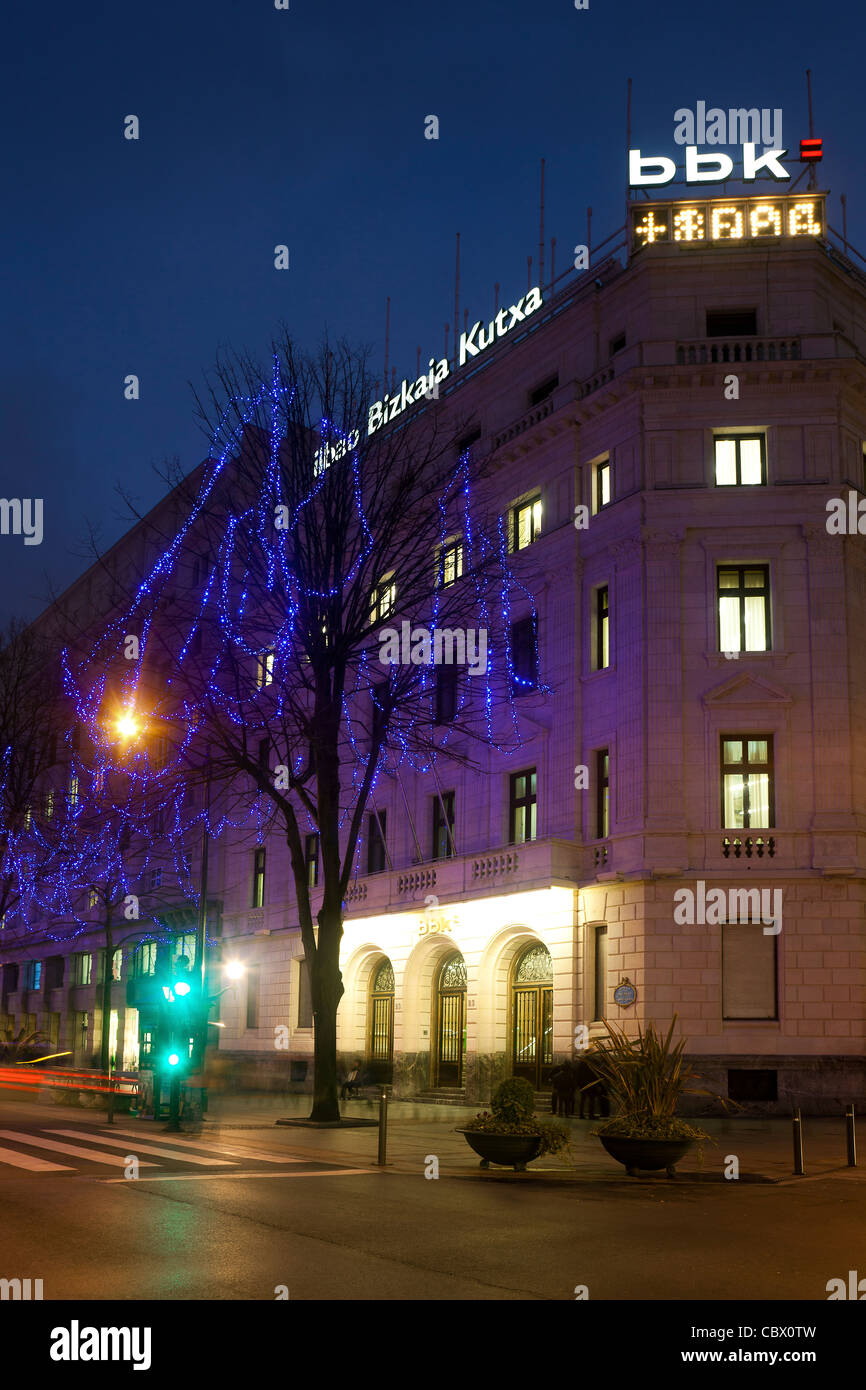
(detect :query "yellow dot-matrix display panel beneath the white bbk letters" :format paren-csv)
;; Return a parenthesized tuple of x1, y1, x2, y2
(631, 193, 824, 250)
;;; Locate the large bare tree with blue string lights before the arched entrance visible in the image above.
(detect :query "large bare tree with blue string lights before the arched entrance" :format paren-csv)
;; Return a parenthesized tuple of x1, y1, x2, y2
(67, 335, 544, 1120)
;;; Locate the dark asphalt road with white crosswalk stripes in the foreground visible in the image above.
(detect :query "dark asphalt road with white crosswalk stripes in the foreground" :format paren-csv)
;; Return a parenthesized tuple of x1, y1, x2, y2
(0, 1105, 866, 1301)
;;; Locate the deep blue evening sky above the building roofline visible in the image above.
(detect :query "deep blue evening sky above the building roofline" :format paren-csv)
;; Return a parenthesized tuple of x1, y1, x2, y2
(0, 0, 866, 621)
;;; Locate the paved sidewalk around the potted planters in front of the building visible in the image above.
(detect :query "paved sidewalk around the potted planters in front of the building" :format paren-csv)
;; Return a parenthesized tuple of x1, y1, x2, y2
(203, 1095, 866, 1183)
